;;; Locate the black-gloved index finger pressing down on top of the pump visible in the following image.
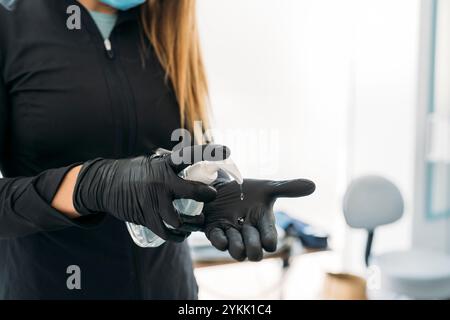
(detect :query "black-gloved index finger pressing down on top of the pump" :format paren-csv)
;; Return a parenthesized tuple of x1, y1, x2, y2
(167, 144, 231, 173)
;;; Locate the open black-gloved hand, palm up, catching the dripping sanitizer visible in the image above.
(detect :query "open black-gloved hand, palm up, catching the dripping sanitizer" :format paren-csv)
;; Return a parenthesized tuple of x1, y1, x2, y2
(203, 180, 315, 261)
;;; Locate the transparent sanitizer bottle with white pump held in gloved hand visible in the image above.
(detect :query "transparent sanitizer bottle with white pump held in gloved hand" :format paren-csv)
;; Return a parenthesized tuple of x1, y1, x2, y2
(126, 159, 244, 248)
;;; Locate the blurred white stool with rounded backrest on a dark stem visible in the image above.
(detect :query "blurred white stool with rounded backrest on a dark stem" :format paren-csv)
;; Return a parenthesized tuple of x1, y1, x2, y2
(343, 176, 450, 299)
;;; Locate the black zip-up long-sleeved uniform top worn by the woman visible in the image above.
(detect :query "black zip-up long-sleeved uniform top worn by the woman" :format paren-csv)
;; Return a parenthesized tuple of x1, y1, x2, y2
(0, 0, 197, 299)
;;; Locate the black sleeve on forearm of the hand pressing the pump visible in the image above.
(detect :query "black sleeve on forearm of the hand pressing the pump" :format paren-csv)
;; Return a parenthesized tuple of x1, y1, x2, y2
(0, 75, 103, 238)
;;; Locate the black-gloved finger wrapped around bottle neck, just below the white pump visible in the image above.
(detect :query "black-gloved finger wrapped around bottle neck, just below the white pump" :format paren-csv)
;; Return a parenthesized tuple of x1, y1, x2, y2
(172, 178, 217, 202)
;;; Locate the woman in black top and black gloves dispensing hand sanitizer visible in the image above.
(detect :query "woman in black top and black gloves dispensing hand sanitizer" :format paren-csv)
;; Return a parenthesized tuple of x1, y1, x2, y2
(0, 0, 314, 299)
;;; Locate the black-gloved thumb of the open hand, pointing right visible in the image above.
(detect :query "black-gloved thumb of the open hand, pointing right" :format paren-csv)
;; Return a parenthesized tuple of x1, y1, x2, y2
(269, 179, 316, 198)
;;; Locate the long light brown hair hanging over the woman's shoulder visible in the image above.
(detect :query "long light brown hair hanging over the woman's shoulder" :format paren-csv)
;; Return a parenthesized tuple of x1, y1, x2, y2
(141, 0, 209, 130)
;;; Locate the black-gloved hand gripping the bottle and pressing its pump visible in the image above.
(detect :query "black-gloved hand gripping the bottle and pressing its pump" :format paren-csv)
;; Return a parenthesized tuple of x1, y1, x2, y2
(74, 145, 230, 242)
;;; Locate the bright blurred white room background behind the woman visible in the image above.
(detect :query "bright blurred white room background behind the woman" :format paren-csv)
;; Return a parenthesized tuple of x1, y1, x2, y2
(189, 0, 450, 299)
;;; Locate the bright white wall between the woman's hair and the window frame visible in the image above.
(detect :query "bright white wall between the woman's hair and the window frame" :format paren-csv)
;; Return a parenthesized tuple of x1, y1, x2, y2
(199, 0, 419, 272)
